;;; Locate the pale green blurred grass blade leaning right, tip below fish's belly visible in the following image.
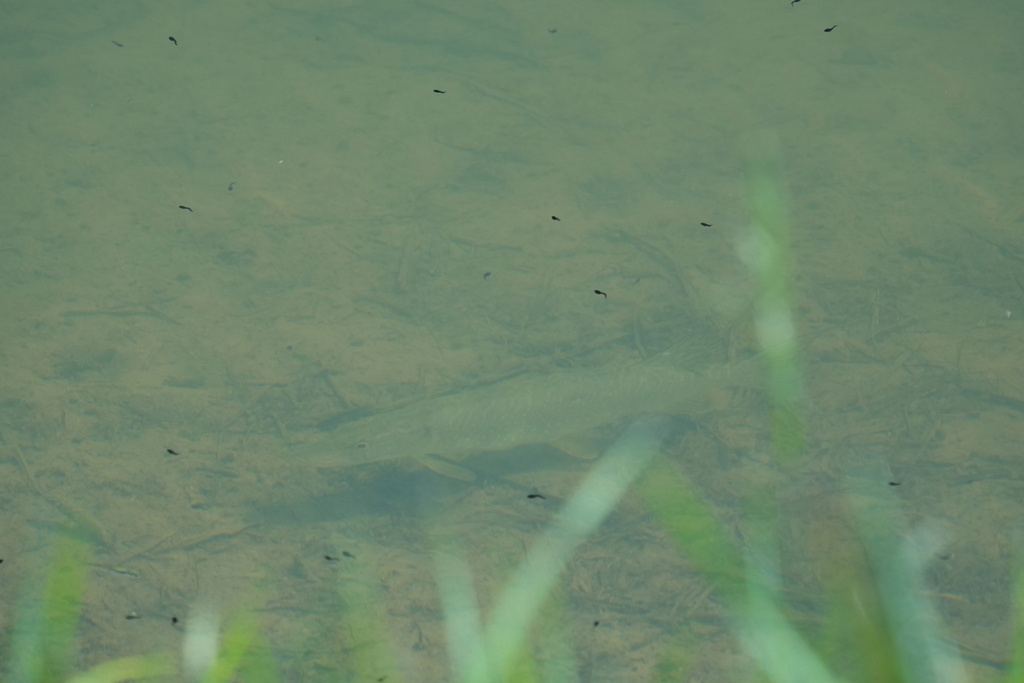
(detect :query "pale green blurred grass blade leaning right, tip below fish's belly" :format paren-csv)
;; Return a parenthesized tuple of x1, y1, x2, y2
(460, 419, 666, 683)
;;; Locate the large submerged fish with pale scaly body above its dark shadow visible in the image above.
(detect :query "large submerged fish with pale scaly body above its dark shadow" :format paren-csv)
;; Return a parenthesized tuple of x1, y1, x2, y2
(292, 360, 759, 478)
